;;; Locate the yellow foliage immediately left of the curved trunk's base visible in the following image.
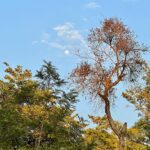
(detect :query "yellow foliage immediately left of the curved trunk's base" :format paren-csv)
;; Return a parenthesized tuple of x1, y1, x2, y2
(84, 116, 118, 150)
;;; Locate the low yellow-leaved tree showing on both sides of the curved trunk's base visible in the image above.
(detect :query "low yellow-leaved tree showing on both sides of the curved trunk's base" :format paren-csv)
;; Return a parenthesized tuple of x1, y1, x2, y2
(84, 116, 146, 150)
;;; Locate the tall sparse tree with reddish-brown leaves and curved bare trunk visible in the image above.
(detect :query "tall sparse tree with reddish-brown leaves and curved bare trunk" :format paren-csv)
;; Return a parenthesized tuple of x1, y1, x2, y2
(71, 18, 147, 150)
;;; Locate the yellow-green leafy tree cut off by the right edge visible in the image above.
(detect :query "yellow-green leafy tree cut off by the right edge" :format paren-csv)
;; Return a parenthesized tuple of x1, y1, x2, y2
(123, 67, 150, 145)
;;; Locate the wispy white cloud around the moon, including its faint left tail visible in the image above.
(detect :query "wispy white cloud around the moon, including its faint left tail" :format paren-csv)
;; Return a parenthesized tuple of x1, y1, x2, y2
(32, 22, 88, 55)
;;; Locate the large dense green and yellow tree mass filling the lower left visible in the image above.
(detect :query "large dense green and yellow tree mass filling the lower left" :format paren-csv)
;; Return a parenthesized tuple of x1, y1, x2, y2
(0, 63, 85, 150)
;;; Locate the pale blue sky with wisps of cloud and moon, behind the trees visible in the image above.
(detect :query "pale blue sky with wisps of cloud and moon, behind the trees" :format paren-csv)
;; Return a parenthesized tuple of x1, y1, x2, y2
(0, 0, 150, 126)
